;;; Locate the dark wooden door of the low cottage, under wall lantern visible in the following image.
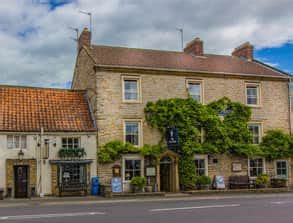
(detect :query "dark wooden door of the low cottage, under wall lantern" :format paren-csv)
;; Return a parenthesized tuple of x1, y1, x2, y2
(14, 166, 28, 198)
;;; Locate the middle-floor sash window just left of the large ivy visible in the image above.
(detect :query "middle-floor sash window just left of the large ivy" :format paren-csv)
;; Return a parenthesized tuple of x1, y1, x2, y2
(124, 121, 140, 146)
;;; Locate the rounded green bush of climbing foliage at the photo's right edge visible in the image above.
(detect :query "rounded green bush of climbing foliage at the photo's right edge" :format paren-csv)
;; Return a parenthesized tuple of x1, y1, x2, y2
(260, 130, 293, 159)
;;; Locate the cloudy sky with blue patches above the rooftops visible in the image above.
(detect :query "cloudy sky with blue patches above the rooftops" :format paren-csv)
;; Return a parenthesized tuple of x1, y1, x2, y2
(0, 0, 293, 88)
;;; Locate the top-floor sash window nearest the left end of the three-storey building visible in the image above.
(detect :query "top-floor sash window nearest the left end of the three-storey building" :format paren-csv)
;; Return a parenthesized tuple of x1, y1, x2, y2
(123, 77, 140, 102)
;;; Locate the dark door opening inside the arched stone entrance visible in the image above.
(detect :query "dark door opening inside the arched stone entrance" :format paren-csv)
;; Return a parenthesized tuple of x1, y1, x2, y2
(160, 156, 172, 192)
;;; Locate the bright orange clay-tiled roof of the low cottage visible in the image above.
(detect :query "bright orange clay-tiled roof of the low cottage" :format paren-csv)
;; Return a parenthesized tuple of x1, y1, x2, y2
(0, 86, 96, 132)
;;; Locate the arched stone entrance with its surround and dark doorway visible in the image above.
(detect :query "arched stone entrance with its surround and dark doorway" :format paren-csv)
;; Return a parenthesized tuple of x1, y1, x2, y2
(157, 150, 179, 192)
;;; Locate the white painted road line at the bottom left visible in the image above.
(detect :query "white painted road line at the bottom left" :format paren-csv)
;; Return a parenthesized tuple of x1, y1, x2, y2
(0, 212, 106, 221)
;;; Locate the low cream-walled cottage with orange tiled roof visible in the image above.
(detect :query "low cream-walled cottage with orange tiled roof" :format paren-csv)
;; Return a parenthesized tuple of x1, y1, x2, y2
(0, 86, 97, 198)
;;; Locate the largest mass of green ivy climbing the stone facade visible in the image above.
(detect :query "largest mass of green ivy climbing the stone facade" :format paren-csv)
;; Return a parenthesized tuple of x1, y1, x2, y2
(145, 98, 251, 188)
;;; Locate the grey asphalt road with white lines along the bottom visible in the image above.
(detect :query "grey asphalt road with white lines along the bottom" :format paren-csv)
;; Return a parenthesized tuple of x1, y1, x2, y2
(0, 194, 293, 223)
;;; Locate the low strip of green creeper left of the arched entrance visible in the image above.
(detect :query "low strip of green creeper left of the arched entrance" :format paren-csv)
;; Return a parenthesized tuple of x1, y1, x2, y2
(98, 140, 163, 163)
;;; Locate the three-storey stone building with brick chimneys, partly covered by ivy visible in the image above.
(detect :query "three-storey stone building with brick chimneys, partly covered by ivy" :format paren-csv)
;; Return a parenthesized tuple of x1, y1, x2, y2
(72, 29, 292, 191)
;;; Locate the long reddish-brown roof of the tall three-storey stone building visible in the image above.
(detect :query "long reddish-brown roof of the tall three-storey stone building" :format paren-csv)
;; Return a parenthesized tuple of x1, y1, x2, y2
(90, 45, 288, 78)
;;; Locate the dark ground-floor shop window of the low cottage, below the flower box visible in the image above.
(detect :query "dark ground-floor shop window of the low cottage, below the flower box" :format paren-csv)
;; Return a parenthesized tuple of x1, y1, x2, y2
(59, 163, 86, 184)
